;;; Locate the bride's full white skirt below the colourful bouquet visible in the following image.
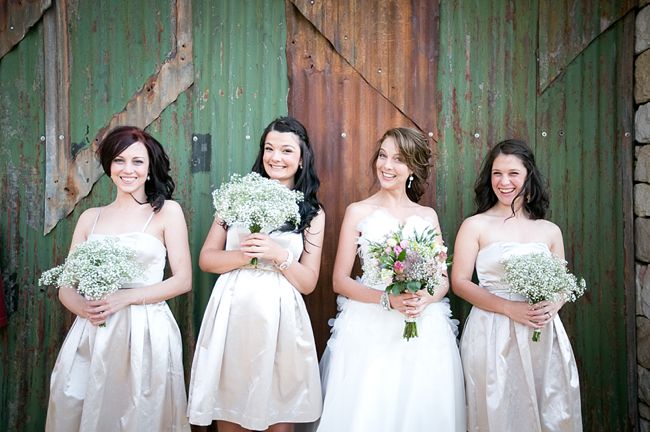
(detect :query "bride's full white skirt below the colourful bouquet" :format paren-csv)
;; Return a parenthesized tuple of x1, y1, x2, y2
(314, 297, 466, 432)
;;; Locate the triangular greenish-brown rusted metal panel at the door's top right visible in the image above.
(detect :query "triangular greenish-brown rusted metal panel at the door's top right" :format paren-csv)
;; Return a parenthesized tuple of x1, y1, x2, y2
(538, 0, 639, 93)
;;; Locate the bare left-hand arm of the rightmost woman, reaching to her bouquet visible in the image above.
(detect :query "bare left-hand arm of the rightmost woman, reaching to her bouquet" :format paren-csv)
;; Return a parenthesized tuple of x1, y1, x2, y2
(451, 218, 542, 328)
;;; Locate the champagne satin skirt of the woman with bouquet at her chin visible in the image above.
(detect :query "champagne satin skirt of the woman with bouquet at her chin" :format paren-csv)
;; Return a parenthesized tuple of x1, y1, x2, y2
(188, 268, 322, 430)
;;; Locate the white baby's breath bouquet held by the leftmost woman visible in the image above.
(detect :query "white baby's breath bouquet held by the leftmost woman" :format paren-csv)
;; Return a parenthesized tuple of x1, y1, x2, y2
(38, 237, 141, 327)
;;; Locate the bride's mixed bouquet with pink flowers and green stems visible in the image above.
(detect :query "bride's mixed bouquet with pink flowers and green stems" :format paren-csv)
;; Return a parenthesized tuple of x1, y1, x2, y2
(364, 225, 447, 340)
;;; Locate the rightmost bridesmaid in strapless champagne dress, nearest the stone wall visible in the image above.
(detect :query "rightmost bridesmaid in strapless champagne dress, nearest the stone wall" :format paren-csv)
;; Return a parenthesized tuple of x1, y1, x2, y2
(451, 140, 582, 432)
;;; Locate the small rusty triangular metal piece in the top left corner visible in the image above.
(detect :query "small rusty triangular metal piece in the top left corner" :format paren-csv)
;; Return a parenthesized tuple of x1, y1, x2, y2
(0, 0, 52, 59)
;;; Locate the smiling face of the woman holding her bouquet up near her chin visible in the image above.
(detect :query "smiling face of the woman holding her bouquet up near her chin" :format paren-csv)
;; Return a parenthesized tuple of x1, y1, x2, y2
(262, 131, 302, 189)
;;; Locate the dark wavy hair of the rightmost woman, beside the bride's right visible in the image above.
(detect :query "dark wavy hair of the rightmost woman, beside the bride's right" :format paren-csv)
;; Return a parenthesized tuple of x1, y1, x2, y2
(474, 139, 549, 219)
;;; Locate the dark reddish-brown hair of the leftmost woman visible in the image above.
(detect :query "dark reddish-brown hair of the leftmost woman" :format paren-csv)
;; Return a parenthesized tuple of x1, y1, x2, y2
(97, 126, 176, 212)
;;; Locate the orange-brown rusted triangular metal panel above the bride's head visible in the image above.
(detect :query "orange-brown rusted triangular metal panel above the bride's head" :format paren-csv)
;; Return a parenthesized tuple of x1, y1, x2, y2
(293, 0, 439, 139)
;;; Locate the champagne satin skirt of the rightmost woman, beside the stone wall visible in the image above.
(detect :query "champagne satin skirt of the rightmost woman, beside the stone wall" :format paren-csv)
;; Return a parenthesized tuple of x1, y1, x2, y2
(461, 307, 582, 432)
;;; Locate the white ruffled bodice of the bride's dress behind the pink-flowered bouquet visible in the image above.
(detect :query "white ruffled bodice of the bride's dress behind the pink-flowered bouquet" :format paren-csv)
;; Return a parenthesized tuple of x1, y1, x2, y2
(357, 207, 433, 291)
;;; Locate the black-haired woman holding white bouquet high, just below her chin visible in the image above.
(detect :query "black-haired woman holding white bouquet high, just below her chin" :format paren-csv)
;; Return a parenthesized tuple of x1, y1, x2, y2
(188, 117, 325, 432)
